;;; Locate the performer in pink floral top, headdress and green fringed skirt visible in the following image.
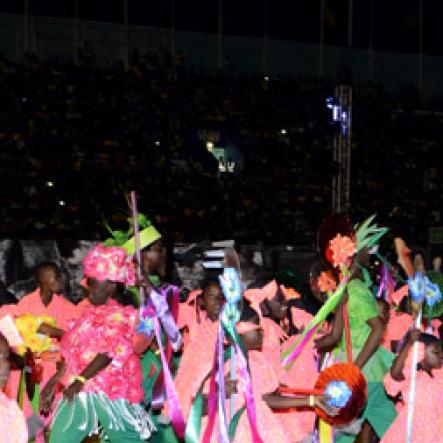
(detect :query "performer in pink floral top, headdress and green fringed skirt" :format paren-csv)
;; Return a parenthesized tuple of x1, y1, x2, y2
(40, 245, 155, 443)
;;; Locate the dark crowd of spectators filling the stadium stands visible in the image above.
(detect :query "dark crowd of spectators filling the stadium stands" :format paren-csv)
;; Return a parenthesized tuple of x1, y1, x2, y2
(0, 50, 443, 250)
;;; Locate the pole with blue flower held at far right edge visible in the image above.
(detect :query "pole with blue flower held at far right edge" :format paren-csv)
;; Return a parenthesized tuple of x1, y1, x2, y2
(395, 238, 442, 443)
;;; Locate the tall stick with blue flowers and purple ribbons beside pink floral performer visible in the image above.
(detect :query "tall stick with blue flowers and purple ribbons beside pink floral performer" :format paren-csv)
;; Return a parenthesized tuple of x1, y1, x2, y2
(131, 191, 185, 439)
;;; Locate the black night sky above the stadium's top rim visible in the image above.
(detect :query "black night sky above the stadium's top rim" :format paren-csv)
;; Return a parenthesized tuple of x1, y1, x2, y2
(0, 0, 443, 55)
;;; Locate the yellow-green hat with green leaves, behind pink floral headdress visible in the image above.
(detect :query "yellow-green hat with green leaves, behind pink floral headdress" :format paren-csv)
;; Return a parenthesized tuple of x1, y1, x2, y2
(103, 213, 161, 255)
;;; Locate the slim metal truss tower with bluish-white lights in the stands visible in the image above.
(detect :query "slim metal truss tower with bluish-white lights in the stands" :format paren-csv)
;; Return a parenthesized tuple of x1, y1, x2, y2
(326, 85, 352, 212)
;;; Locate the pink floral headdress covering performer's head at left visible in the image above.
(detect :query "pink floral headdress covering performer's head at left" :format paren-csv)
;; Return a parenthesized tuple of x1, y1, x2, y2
(83, 244, 136, 286)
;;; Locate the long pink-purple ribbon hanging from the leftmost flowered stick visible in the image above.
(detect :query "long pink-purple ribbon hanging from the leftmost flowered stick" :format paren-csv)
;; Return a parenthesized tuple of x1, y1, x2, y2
(154, 317, 186, 439)
